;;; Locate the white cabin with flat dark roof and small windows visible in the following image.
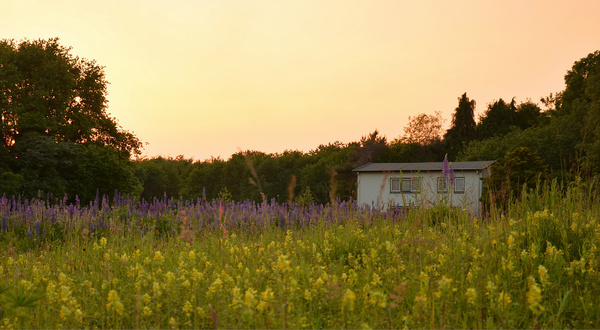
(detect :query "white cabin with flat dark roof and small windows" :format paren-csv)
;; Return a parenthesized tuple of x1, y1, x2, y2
(353, 161, 494, 217)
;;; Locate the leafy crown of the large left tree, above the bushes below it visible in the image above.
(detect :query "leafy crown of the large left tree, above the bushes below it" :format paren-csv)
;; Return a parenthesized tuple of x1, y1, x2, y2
(0, 38, 141, 156)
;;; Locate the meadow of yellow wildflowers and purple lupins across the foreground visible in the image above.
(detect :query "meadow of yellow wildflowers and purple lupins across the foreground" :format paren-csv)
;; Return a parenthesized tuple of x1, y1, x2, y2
(0, 179, 600, 328)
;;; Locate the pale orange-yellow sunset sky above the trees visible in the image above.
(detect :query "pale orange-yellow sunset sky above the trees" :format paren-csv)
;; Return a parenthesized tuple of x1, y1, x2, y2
(0, 0, 600, 161)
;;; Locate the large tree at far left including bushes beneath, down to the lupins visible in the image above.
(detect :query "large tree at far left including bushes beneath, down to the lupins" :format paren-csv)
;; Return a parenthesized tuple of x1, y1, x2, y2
(0, 38, 141, 197)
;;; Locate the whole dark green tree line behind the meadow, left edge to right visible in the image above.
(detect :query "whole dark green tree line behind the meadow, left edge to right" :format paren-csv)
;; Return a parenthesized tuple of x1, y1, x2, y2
(0, 39, 600, 203)
